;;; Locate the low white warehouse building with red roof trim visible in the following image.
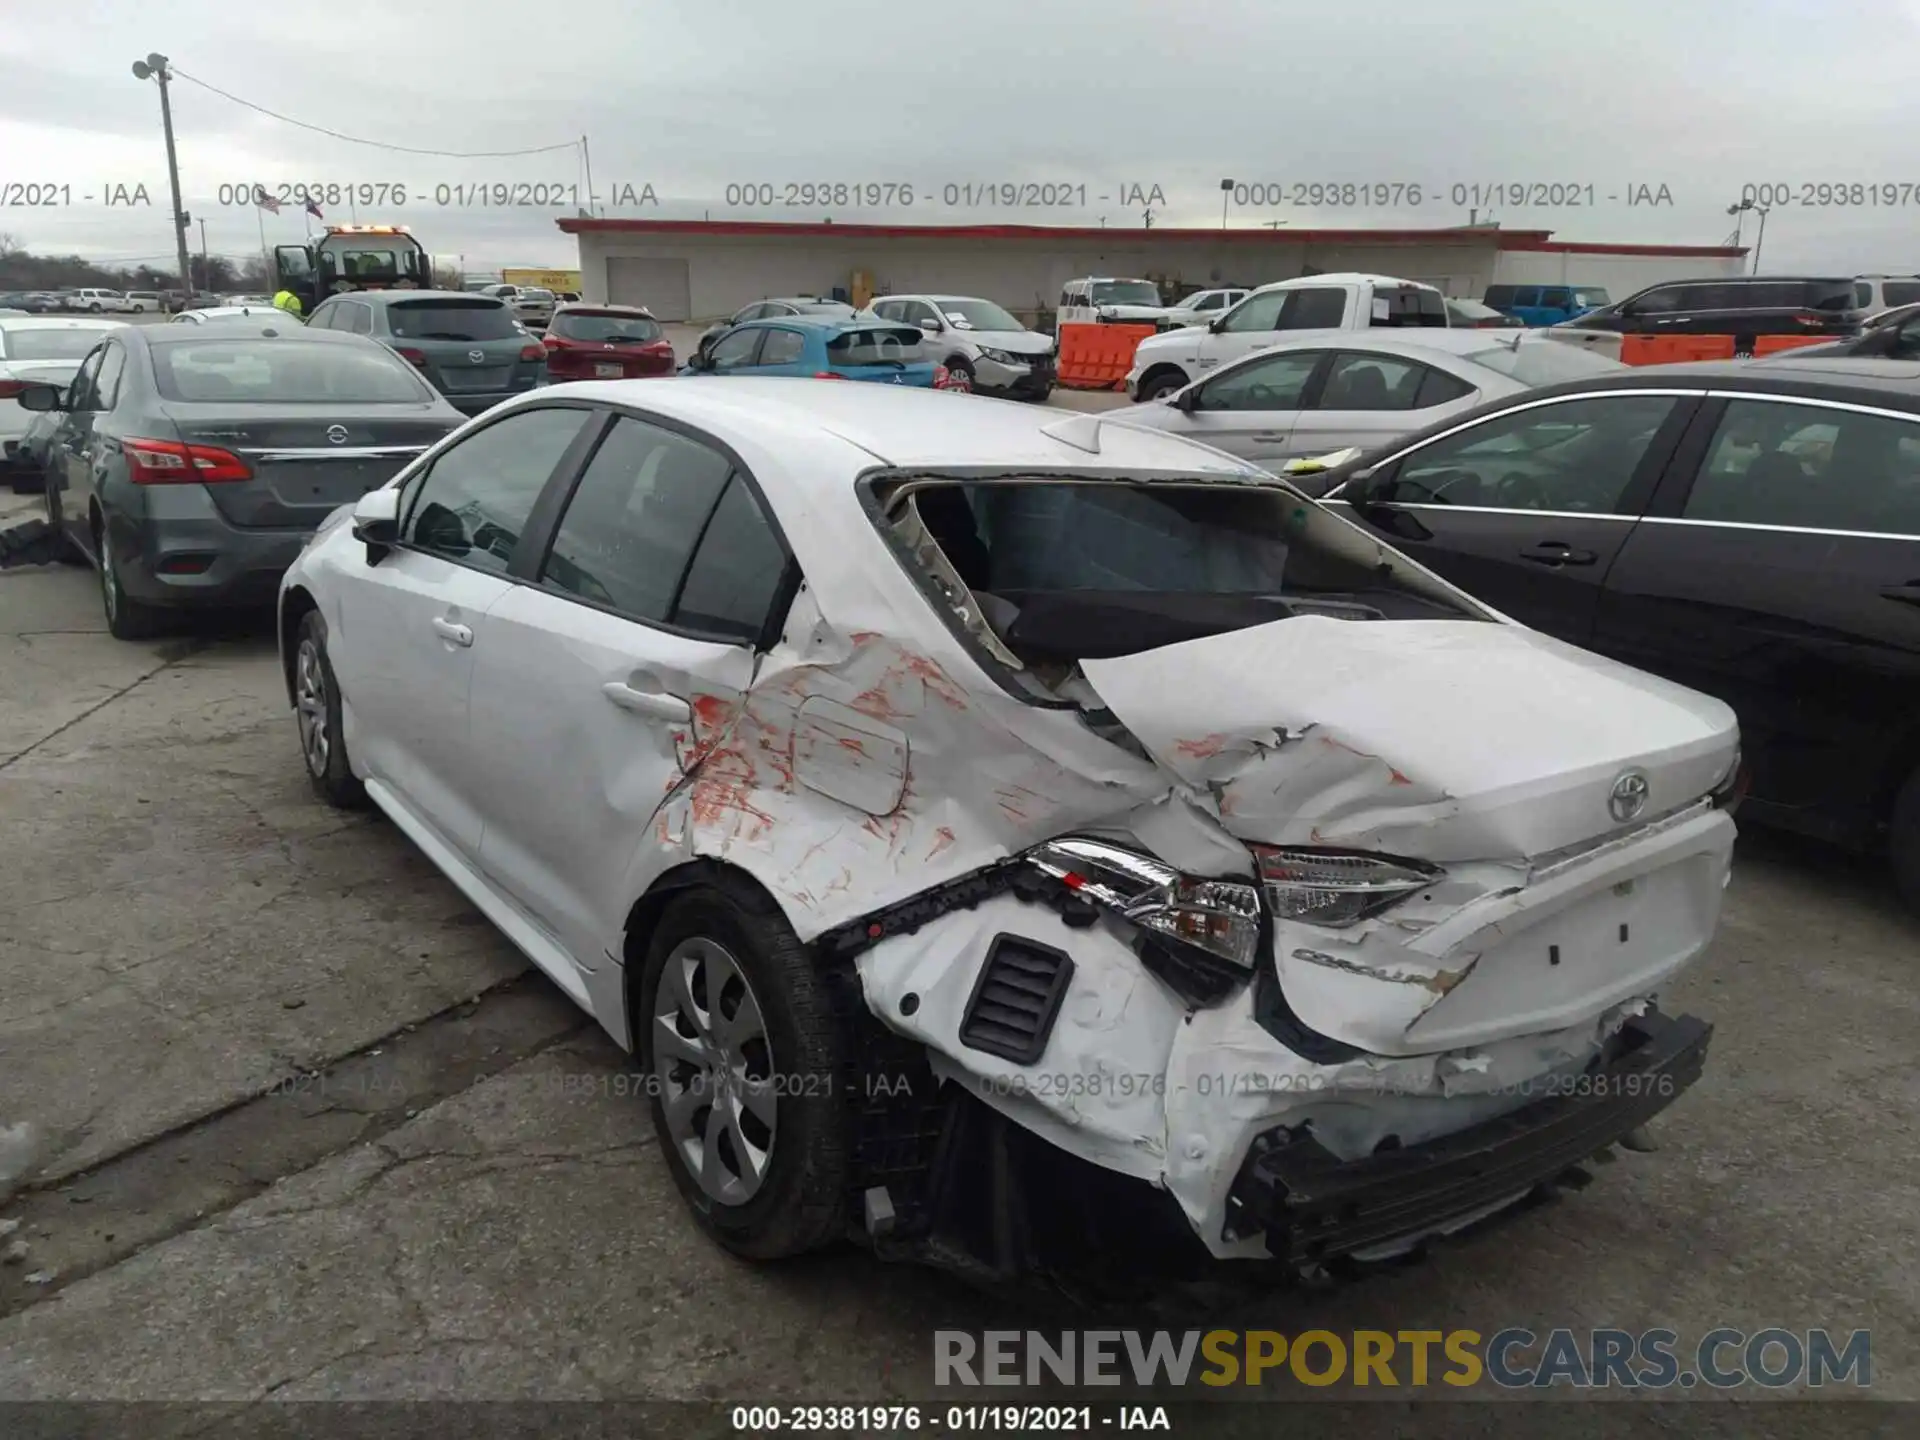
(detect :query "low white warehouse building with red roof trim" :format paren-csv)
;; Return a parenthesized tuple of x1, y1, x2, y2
(559, 217, 1747, 321)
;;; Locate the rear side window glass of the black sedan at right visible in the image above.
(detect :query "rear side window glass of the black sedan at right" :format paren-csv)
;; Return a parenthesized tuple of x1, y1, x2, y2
(1682, 399, 1920, 536)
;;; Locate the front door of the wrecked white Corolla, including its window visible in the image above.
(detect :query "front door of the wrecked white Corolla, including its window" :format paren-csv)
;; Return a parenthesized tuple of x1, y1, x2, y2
(328, 403, 599, 866)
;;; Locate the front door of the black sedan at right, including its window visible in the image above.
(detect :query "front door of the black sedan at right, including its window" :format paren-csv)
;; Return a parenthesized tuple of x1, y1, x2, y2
(1340, 390, 1697, 645)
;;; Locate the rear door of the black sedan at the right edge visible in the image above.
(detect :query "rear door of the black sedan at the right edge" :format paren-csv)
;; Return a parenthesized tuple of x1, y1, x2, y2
(1594, 396, 1920, 843)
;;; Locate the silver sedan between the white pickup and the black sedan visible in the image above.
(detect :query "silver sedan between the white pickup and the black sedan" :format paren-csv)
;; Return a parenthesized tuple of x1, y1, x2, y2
(1110, 330, 1622, 468)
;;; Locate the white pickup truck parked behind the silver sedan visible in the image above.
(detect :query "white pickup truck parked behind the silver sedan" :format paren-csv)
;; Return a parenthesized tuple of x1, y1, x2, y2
(1127, 275, 1448, 401)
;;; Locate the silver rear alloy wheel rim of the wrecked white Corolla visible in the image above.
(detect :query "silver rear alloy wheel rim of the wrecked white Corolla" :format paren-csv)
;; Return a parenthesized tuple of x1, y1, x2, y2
(651, 935, 778, 1206)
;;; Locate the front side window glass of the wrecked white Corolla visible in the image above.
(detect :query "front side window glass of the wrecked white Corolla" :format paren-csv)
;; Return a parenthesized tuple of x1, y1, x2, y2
(407, 407, 593, 574)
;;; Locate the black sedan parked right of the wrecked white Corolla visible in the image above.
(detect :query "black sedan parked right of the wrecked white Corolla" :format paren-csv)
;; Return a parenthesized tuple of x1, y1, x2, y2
(1296, 357, 1920, 908)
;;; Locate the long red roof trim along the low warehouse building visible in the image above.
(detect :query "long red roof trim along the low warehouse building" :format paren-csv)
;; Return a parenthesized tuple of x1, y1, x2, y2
(555, 215, 1747, 259)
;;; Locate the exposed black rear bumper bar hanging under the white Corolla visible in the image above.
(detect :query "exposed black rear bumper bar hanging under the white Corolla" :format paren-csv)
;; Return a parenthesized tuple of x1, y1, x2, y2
(1221, 1012, 1713, 1267)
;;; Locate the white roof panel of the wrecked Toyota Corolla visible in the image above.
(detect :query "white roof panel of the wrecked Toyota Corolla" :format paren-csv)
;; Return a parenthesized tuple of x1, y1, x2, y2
(522, 376, 1275, 480)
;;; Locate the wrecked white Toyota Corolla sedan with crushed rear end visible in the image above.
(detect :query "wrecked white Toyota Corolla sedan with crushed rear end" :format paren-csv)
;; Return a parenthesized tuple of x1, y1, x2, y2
(280, 380, 1738, 1275)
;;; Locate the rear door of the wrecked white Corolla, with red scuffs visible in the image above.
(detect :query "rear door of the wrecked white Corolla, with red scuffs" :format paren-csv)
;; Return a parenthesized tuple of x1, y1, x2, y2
(472, 415, 791, 985)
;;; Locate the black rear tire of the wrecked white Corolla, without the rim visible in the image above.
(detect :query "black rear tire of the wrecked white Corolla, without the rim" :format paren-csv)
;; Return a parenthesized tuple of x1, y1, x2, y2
(634, 876, 851, 1260)
